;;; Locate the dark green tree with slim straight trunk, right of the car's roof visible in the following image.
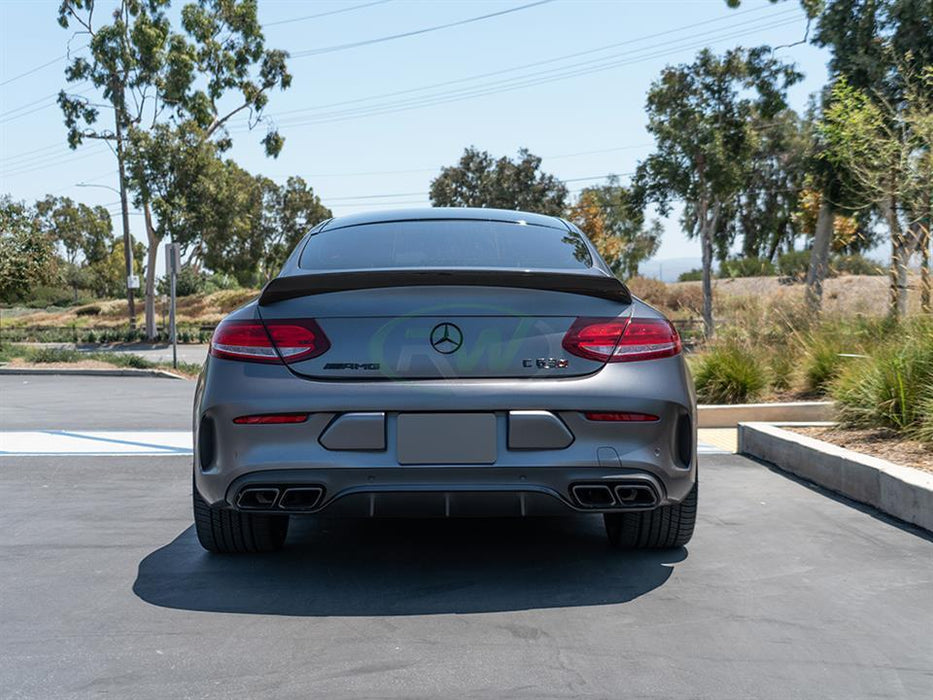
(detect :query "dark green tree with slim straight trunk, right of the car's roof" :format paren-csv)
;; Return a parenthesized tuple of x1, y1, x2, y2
(635, 47, 802, 337)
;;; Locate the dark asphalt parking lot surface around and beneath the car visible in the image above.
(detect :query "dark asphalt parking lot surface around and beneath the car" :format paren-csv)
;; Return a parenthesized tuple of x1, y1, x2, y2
(0, 376, 933, 698)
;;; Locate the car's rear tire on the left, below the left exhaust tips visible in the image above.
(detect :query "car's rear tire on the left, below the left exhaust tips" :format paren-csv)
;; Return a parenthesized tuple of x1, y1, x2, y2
(192, 487, 288, 554)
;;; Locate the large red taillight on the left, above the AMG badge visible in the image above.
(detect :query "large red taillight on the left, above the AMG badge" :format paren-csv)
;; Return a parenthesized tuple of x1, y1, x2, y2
(211, 319, 330, 364)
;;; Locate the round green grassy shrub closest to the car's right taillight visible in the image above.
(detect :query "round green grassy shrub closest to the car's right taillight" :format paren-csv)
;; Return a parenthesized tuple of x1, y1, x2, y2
(694, 342, 768, 404)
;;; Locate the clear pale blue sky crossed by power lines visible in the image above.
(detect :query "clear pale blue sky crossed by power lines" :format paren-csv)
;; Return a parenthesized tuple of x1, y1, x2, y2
(0, 0, 827, 274)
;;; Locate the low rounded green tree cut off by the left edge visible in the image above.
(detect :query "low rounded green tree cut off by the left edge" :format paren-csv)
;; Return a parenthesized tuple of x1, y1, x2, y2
(0, 195, 57, 303)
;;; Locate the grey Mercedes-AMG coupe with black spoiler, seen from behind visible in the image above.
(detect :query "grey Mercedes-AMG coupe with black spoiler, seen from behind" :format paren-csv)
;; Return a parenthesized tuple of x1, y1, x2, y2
(193, 209, 697, 553)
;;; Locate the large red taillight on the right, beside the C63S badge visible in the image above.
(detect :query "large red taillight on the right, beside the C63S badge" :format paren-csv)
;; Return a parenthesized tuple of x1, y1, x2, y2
(563, 318, 681, 362)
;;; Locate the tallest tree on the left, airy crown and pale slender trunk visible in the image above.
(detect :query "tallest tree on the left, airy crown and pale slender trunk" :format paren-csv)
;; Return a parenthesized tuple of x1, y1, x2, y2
(58, 0, 291, 337)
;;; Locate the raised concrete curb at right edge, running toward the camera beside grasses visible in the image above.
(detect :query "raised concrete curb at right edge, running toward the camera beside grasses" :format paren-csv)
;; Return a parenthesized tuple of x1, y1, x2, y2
(738, 423, 933, 531)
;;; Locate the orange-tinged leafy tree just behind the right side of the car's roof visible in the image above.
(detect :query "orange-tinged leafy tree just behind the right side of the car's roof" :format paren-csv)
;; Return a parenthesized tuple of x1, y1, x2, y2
(567, 178, 662, 278)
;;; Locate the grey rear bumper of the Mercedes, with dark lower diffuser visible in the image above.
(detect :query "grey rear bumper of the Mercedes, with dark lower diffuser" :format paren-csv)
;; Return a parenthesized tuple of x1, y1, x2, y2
(194, 357, 696, 517)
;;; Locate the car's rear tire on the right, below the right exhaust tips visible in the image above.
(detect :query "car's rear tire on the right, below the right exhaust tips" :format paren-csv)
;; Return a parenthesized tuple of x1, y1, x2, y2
(603, 484, 698, 549)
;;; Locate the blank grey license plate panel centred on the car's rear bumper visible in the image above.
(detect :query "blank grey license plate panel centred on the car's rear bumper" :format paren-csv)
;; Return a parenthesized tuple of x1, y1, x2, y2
(397, 413, 497, 464)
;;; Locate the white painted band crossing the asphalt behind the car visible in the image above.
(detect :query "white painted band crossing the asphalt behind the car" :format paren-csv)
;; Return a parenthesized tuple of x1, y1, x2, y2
(0, 430, 729, 457)
